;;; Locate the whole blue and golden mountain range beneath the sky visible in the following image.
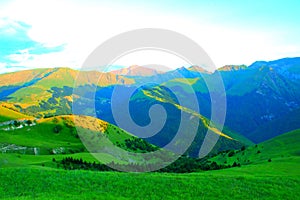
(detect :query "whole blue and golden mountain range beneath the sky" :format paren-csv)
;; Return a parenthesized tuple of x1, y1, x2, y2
(0, 58, 300, 156)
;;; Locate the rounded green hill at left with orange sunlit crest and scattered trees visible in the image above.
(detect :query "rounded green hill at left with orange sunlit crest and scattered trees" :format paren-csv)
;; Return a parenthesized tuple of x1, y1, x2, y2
(0, 115, 162, 168)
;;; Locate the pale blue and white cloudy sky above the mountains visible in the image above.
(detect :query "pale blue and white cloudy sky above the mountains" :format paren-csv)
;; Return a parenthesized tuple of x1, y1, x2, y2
(0, 0, 300, 73)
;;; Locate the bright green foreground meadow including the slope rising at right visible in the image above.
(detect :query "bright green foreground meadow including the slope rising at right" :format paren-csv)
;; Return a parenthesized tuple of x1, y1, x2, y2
(0, 130, 300, 199)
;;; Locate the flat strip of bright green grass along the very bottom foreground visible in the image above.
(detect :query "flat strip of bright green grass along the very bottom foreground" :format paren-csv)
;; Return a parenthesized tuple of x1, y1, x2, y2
(0, 168, 300, 199)
